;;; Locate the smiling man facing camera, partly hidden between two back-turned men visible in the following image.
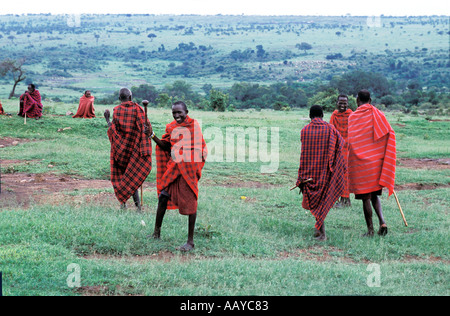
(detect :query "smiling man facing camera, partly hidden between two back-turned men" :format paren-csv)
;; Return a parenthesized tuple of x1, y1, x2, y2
(330, 94, 353, 207)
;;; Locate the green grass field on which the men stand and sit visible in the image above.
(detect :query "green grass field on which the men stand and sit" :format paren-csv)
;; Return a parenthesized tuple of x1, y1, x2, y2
(0, 99, 450, 296)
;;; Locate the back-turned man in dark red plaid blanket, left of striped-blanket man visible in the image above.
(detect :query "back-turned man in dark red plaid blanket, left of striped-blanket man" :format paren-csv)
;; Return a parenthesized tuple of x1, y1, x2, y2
(296, 105, 347, 240)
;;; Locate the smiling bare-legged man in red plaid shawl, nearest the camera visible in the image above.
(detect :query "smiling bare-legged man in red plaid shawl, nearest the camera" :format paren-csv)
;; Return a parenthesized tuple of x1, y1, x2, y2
(152, 101, 207, 251)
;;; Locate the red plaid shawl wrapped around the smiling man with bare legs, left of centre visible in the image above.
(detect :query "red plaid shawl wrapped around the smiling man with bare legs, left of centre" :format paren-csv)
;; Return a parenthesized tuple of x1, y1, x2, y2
(155, 116, 207, 209)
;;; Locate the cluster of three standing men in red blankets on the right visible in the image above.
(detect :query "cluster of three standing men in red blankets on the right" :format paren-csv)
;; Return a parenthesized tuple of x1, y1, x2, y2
(296, 90, 396, 240)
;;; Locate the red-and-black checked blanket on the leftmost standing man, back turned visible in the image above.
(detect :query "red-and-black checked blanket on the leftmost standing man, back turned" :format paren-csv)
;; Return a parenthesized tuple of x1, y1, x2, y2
(108, 101, 152, 203)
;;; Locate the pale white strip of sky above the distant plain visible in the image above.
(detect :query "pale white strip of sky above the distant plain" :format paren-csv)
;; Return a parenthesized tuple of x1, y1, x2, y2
(0, 0, 450, 16)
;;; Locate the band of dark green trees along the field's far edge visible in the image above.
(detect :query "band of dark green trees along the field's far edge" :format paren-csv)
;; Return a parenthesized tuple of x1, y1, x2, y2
(97, 70, 450, 114)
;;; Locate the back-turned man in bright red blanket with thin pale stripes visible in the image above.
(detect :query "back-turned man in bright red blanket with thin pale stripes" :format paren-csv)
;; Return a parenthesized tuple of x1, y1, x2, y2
(348, 90, 396, 236)
